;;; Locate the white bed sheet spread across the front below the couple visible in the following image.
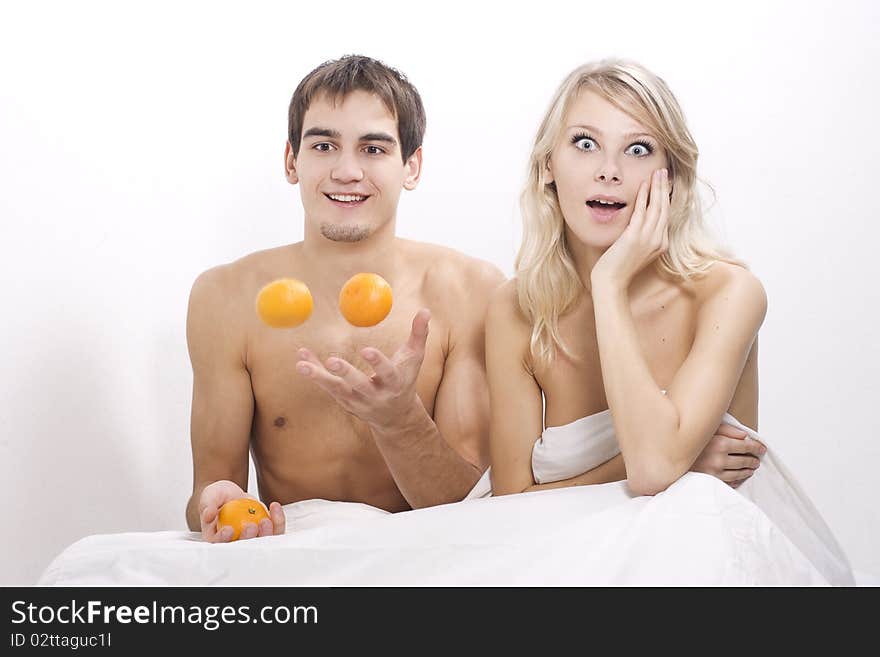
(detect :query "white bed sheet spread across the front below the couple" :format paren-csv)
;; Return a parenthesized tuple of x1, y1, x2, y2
(38, 473, 833, 586)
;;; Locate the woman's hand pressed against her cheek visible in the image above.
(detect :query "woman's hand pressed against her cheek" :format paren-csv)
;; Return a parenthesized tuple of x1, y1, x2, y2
(590, 169, 669, 290)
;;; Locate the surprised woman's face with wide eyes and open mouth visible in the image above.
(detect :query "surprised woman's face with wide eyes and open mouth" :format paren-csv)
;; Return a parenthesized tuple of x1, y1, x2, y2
(550, 89, 668, 249)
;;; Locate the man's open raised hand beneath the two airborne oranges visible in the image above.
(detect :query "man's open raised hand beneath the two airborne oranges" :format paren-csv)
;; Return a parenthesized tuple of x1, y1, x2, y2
(296, 308, 431, 427)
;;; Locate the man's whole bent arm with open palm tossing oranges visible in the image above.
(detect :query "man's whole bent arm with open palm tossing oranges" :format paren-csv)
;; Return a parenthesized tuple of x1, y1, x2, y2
(297, 265, 504, 508)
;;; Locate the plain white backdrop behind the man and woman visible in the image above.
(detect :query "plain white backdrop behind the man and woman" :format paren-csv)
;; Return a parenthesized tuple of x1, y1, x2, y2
(0, 0, 880, 585)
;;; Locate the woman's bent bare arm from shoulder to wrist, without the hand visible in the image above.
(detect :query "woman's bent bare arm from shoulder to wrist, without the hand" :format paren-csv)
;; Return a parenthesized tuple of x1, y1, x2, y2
(593, 268, 767, 495)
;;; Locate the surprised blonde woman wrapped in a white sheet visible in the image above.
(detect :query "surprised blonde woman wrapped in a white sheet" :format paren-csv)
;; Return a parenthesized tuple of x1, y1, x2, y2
(471, 61, 852, 583)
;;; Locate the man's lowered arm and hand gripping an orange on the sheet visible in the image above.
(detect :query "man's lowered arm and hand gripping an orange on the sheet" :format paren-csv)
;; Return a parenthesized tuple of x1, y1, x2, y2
(186, 267, 283, 540)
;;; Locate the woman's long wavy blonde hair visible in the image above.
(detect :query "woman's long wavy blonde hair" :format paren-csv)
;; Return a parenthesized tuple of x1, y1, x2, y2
(515, 60, 742, 365)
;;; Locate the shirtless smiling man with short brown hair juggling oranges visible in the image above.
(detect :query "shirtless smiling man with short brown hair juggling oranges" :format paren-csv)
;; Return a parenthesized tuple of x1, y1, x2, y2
(186, 56, 504, 542)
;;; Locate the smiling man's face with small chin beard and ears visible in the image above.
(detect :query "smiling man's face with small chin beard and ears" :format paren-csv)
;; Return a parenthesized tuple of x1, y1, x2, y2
(285, 91, 422, 242)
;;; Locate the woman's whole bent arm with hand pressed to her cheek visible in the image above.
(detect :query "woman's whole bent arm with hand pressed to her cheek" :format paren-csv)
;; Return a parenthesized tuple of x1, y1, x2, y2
(590, 169, 767, 495)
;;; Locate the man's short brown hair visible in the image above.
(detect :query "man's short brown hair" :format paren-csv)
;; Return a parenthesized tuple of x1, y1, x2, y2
(287, 55, 425, 162)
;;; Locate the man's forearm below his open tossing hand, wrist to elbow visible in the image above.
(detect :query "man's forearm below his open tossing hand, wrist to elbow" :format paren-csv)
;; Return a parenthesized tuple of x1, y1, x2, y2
(371, 402, 481, 509)
